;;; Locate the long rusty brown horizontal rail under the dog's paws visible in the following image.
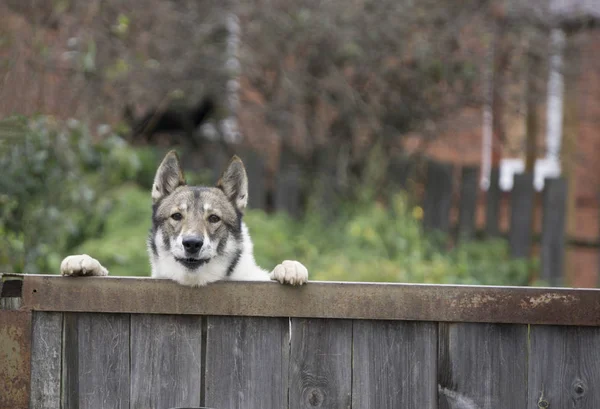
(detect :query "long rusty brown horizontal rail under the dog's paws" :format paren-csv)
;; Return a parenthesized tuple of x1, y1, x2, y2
(16, 275, 600, 326)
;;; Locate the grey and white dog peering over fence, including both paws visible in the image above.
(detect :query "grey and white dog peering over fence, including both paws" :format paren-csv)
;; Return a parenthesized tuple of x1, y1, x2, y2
(60, 151, 308, 286)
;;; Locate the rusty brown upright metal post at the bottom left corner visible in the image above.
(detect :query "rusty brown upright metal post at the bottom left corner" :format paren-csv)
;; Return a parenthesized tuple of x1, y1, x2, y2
(0, 310, 31, 409)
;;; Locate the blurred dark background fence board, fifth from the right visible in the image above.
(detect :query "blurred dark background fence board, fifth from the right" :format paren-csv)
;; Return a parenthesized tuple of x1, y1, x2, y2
(423, 161, 453, 233)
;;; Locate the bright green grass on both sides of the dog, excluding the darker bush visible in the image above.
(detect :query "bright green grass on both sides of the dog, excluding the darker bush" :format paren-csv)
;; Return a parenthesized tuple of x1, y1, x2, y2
(77, 184, 532, 285)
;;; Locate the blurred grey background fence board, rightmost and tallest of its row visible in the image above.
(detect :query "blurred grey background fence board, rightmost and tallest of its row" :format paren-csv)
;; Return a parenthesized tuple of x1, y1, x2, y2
(540, 177, 567, 286)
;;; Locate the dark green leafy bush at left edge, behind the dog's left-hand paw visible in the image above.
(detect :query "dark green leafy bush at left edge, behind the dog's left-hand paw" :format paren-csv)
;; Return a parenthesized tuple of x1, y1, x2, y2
(0, 116, 140, 273)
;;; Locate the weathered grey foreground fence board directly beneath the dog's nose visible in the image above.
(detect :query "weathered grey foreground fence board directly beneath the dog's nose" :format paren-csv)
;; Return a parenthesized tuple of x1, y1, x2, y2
(131, 314, 202, 409)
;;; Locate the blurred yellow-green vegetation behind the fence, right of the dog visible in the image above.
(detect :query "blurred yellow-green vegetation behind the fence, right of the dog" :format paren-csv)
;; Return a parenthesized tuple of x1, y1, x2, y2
(246, 195, 536, 285)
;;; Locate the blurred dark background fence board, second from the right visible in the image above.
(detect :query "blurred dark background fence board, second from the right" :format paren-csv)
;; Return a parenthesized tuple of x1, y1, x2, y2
(508, 173, 534, 258)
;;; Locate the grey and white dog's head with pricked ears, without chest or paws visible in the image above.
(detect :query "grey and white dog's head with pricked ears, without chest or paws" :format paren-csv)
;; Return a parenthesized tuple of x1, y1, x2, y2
(150, 151, 248, 272)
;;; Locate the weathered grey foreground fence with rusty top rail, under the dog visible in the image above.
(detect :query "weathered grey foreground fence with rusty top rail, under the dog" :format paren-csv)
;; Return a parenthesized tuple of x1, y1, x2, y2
(0, 276, 600, 409)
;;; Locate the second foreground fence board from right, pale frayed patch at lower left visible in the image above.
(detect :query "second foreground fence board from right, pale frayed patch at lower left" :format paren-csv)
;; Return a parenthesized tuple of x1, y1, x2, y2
(438, 323, 527, 409)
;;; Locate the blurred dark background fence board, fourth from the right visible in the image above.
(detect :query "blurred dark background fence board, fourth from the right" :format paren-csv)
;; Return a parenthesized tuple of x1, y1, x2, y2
(458, 167, 479, 239)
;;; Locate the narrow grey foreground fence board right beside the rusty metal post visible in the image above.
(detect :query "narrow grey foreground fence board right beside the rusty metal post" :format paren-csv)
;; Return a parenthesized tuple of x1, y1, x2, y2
(29, 312, 63, 409)
